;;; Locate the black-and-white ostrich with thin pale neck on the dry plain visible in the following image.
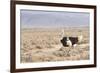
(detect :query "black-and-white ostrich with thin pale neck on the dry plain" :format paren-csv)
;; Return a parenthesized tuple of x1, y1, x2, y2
(60, 30, 83, 47)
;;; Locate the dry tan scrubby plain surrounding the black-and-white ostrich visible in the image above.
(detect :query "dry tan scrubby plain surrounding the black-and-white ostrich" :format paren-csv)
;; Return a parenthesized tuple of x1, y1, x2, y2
(20, 27, 89, 63)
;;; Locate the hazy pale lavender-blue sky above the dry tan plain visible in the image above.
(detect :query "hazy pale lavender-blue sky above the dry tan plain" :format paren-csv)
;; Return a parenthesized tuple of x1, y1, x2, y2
(20, 10, 90, 28)
